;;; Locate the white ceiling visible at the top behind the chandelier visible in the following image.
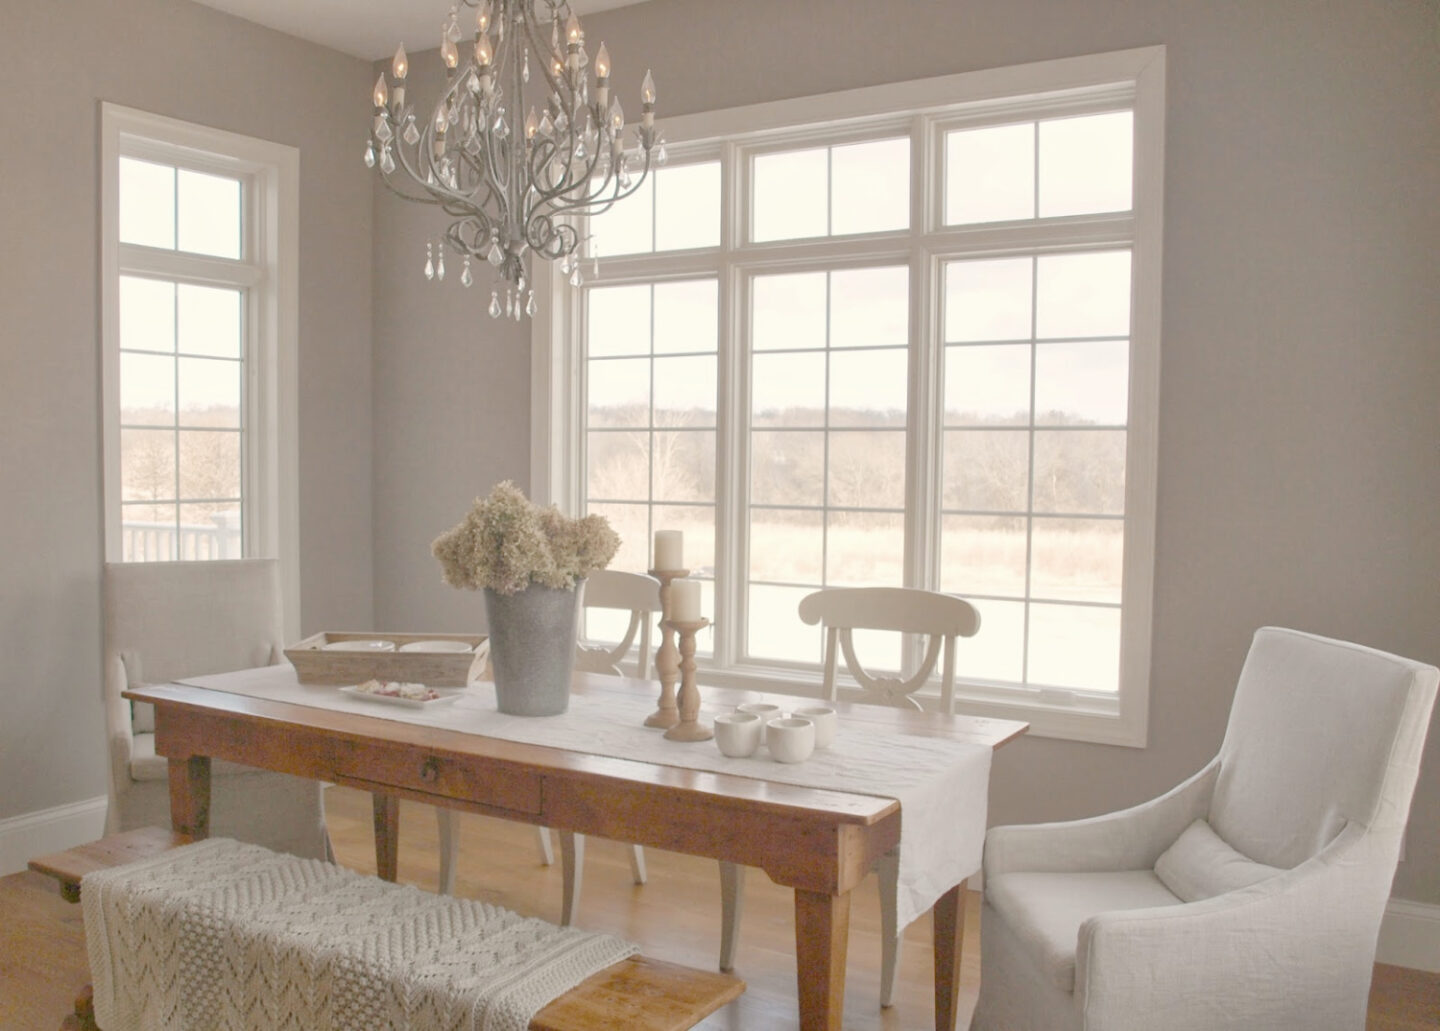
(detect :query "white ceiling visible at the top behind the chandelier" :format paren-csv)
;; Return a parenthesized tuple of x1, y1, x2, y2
(188, 0, 644, 60)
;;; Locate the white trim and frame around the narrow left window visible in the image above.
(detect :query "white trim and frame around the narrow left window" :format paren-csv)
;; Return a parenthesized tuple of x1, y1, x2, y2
(99, 102, 300, 639)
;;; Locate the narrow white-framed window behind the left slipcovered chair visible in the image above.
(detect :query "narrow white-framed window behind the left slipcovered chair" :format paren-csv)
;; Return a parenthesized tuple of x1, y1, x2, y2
(102, 105, 297, 627)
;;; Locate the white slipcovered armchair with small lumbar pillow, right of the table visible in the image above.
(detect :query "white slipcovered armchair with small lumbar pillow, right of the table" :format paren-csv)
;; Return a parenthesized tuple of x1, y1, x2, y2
(971, 628, 1440, 1031)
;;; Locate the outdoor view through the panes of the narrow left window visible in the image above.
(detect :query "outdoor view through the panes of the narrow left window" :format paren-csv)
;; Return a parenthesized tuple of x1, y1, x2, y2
(118, 157, 246, 562)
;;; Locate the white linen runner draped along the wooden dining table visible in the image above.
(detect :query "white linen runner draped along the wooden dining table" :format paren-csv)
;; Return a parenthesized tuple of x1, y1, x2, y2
(179, 664, 991, 927)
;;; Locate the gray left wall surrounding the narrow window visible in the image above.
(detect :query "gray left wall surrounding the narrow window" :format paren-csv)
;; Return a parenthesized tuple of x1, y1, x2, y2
(0, 0, 373, 819)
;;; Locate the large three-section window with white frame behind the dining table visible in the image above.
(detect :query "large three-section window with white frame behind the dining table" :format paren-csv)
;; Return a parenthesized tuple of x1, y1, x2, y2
(534, 49, 1164, 744)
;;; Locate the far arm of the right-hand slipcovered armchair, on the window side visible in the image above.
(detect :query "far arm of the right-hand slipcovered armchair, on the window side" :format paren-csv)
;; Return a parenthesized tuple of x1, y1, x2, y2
(985, 759, 1220, 877)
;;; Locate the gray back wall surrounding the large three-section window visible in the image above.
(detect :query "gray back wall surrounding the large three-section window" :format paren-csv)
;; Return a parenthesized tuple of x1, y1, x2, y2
(374, 0, 1440, 903)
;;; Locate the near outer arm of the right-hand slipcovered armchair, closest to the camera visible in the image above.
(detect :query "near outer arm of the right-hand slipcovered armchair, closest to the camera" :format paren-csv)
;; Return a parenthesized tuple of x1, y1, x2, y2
(1076, 824, 1394, 1031)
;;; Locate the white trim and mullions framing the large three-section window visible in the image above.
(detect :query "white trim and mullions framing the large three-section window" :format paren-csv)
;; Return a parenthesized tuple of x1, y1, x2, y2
(530, 46, 1165, 747)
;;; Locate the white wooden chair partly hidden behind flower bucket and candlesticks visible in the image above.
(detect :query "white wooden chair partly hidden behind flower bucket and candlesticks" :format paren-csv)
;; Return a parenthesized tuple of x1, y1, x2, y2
(435, 569, 660, 927)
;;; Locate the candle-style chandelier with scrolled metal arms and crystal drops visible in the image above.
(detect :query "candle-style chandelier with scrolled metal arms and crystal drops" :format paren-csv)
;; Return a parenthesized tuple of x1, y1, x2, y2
(364, 0, 665, 320)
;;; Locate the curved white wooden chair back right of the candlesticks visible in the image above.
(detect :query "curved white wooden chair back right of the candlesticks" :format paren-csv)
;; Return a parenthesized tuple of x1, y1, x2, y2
(799, 587, 981, 713)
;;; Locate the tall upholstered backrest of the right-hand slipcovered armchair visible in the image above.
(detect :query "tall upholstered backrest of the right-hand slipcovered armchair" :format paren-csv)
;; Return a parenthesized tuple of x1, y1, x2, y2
(1210, 626, 1440, 890)
